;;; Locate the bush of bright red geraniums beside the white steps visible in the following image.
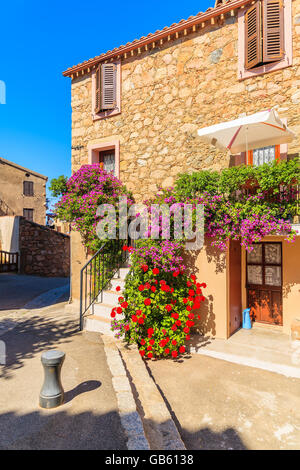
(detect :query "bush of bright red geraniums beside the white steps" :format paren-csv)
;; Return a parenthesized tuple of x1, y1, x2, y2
(111, 266, 205, 359)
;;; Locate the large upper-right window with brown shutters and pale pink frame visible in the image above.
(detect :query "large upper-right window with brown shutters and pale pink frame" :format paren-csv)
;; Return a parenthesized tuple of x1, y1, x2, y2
(238, 0, 292, 79)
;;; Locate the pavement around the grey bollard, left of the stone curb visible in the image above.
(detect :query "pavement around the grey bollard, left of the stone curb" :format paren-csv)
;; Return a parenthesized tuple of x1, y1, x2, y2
(0, 303, 126, 450)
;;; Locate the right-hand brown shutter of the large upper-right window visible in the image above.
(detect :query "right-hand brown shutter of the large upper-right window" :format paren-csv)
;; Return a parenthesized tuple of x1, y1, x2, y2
(263, 0, 284, 62)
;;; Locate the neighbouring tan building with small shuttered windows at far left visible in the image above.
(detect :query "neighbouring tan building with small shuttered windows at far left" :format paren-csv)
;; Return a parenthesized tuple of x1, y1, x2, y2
(0, 158, 48, 225)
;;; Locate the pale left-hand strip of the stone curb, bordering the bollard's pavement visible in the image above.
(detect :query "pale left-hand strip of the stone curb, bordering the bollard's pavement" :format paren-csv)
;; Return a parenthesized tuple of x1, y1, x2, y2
(101, 335, 150, 450)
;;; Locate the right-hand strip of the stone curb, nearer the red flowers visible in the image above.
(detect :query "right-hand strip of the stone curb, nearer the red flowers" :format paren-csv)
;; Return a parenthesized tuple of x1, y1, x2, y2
(116, 338, 186, 450)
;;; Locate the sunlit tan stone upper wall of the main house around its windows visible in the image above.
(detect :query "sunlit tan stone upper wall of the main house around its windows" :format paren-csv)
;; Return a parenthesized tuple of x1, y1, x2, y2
(72, 0, 300, 200)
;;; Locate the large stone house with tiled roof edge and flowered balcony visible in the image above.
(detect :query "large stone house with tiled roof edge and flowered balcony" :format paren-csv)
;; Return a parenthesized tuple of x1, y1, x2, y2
(63, 0, 300, 338)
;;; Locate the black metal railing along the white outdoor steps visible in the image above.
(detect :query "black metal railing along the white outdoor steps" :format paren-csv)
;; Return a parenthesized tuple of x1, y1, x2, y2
(79, 240, 128, 330)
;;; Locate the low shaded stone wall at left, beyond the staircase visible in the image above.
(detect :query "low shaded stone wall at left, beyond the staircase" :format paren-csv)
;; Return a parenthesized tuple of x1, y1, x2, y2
(19, 217, 70, 277)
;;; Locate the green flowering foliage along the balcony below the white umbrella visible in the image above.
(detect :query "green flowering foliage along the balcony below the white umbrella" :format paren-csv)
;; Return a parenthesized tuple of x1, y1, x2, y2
(174, 159, 300, 219)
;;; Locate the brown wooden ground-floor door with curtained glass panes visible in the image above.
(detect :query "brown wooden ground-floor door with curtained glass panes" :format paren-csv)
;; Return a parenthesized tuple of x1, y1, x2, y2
(246, 242, 282, 325)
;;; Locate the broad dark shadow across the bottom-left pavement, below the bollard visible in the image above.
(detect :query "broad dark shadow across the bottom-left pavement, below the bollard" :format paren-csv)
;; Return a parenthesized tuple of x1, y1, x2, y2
(0, 409, 126, 450)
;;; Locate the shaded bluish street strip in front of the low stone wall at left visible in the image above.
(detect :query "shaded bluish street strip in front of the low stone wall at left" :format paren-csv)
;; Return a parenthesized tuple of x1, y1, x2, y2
(0, 273, 70, 315)
